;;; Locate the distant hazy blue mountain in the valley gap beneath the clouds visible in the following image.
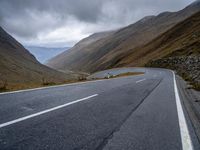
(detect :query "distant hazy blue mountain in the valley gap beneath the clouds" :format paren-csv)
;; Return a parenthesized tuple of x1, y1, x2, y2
(25, 46, 70, 63)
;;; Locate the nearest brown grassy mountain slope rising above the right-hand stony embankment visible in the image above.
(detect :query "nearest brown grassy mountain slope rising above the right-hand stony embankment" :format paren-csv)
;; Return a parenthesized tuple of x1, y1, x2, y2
(114, 11, 200, 67)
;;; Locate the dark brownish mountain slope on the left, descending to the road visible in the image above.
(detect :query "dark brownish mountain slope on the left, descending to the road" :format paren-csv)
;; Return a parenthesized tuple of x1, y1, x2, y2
(0, 27, 76, 90)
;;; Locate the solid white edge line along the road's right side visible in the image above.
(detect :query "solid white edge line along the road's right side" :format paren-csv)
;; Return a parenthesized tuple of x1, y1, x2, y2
(172, 71, 193, 150)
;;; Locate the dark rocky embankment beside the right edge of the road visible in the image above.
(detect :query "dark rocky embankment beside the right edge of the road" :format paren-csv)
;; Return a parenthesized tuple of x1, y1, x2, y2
(145, 56, 200, 90)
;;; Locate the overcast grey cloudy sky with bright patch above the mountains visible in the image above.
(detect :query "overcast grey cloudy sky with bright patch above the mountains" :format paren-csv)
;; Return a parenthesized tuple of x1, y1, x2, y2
(0, 0, 194, 47)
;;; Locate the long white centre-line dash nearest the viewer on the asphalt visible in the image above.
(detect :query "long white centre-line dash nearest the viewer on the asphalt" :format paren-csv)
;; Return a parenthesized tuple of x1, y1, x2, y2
(0, 94, 98, 128)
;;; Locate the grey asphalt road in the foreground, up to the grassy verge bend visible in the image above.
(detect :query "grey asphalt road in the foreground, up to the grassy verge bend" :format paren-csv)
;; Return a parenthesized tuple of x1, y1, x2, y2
(0, 69, 199, 150)
